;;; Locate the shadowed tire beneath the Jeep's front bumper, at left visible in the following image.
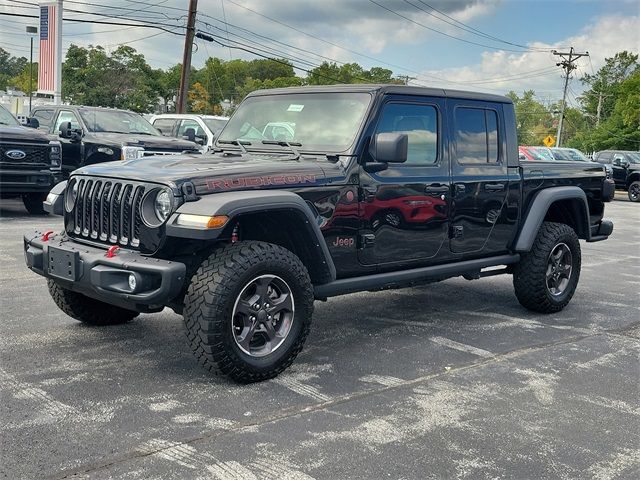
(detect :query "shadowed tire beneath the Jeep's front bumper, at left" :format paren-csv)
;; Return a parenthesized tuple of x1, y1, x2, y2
(47, 279, 139, 326)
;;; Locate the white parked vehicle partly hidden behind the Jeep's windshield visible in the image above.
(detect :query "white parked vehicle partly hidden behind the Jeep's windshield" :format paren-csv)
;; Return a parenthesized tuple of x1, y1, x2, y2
(150, 113, 229, 151)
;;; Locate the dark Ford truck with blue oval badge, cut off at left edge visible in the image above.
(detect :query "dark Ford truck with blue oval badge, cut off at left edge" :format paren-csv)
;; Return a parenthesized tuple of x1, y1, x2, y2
(0, 106, 62, 213)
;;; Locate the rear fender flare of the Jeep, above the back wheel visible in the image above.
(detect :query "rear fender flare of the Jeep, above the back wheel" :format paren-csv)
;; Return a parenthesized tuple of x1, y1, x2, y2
(514, 186, 591, 252)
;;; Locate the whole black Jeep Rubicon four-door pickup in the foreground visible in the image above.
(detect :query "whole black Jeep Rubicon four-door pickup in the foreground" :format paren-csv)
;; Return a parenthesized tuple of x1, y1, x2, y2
(24, 85, 613, 382)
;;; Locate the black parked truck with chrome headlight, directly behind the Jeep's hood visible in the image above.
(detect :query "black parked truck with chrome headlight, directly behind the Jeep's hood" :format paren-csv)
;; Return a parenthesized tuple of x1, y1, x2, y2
(32, 105, 199, 178)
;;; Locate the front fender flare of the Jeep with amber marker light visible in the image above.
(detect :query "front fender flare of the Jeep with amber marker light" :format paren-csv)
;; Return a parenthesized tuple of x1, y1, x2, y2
(166, 190, 336, 280)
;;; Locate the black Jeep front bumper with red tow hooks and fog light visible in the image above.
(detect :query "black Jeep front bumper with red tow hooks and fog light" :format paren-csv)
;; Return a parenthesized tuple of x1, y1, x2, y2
(24, 230, 186, 312)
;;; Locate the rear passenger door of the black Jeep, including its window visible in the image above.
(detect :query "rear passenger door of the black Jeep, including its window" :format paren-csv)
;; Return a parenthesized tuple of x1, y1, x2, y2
(447, 99, 513, 254)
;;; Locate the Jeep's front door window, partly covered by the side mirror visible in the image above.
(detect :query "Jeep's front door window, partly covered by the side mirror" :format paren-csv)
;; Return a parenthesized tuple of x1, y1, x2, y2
(376, 103, 438, 165)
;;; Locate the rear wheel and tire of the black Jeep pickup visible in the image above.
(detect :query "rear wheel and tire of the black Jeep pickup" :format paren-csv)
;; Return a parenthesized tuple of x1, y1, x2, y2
(513, 222, 581, 313)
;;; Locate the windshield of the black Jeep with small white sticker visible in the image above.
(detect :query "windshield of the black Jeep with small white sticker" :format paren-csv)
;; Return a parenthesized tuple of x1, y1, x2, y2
(218, 93, 371, 152)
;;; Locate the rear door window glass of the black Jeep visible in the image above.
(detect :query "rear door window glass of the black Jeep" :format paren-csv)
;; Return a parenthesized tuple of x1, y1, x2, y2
(455, 107, 500, 164)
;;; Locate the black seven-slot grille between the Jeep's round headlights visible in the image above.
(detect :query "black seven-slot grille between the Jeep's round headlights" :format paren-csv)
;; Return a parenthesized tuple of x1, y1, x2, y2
(71, 177, 145, 248)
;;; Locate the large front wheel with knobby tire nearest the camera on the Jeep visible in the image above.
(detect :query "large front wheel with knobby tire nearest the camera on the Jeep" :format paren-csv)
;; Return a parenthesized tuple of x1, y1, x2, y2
(183, 241, 314, 383)
